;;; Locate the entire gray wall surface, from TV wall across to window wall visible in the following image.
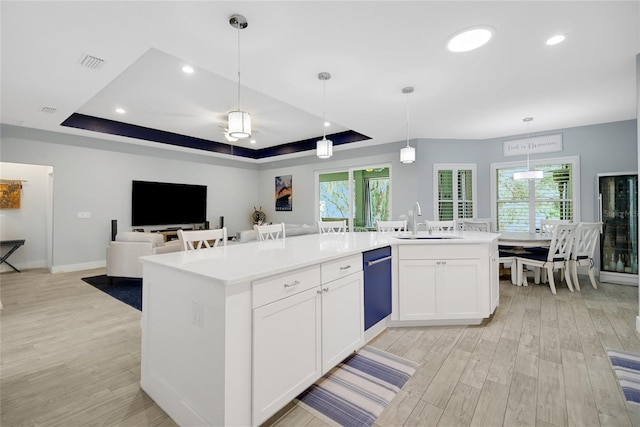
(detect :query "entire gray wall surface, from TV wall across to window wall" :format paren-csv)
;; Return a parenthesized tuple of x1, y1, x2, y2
(0, 120, 638, 271)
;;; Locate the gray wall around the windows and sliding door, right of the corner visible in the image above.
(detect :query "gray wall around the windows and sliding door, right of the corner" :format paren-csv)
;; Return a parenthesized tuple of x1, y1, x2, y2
(260, 120, 638, 227)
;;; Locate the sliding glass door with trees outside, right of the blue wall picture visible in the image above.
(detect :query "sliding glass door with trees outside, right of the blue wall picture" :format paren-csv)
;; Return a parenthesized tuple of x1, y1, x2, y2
(317, 166, 391, 231)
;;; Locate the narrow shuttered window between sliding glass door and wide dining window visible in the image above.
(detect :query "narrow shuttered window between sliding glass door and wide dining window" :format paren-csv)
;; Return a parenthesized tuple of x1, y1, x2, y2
(433, 164, 476, 221)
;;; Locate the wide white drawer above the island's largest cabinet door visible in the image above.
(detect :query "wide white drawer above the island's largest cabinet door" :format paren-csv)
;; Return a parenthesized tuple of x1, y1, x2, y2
(252, 267, 320, 308)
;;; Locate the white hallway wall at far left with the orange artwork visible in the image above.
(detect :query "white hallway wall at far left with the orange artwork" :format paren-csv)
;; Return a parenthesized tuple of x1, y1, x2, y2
(0, 162, 53, 272)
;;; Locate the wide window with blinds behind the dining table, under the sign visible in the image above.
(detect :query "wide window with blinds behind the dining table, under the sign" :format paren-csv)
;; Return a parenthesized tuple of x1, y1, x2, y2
(491, 157, 580, 232)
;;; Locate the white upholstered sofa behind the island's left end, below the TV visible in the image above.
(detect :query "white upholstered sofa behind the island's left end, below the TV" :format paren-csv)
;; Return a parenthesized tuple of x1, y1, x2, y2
(107, 231, 183, 278)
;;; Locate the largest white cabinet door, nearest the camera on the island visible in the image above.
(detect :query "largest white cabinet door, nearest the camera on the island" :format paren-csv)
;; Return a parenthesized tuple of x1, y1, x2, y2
(253, 287, 321, 425)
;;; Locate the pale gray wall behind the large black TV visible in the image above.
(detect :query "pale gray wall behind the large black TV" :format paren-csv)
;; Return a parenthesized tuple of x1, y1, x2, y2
(1, 126, 259, 272)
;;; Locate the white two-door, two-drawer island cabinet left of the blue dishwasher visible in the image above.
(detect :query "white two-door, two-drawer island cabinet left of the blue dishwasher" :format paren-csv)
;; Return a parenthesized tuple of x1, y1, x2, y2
(252, 255, 364, 425)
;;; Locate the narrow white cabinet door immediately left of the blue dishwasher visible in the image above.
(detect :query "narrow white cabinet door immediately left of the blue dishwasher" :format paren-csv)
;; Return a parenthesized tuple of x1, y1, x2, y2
(322, 272, 364, 374)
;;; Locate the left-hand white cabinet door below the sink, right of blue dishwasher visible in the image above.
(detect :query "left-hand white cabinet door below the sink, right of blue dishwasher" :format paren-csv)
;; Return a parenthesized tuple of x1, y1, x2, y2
(398, 259, 438, 320)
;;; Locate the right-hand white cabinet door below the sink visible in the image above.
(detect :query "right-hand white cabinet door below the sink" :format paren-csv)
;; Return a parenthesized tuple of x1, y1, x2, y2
(436, 259, 486, 319)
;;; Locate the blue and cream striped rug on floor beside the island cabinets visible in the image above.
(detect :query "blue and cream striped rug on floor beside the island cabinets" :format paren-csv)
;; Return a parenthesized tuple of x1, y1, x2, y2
(296, 346, 419, 427)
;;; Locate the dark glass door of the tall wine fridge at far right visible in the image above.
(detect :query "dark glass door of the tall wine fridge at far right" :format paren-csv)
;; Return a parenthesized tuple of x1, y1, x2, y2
(598, 173, 638, 286)
